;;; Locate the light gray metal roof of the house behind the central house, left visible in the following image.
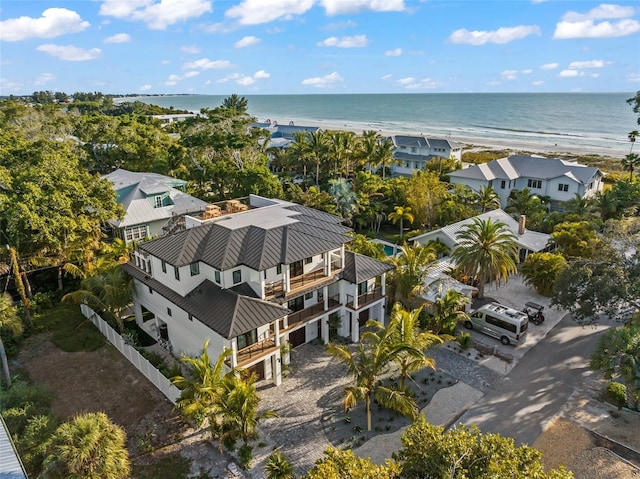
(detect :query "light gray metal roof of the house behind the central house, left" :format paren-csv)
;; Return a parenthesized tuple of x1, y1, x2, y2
(104, 169, 207, 228)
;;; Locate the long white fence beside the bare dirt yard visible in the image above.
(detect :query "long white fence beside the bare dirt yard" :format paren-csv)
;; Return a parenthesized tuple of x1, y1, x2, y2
(80, 304, 180, 404)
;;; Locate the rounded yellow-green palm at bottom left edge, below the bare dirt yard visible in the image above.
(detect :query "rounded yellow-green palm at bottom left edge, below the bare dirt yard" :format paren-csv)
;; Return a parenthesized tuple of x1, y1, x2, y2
(38, 412, 131, 479)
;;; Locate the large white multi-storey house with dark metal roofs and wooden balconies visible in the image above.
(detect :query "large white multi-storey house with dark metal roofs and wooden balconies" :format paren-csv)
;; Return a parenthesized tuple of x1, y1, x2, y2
(124, 195, 392, 384)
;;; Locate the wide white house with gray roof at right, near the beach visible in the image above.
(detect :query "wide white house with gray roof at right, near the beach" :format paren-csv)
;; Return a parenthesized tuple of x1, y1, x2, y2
(448, 155, 603, 211)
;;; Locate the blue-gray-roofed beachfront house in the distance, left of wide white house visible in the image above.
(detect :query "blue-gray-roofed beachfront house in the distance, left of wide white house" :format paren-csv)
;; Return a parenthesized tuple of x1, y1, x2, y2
(389, 135, 462, 176)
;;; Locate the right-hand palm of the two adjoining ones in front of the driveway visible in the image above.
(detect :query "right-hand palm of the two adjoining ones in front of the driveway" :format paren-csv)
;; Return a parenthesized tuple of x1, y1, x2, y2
(387, 303, 444, 389)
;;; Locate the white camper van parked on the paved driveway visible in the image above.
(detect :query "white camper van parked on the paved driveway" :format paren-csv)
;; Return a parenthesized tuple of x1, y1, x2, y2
(464, 303, 529, 344)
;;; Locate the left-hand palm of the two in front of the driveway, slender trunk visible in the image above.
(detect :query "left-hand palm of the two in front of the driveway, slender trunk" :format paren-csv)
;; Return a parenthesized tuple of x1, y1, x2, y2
(327, 321, 421, 431)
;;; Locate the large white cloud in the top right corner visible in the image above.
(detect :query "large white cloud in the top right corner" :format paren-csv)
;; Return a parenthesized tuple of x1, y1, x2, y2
(553, 3, 640, 40)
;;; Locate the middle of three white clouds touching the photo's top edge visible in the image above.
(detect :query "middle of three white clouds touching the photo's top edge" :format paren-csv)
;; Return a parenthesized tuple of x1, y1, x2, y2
(224, 0, 314, 25)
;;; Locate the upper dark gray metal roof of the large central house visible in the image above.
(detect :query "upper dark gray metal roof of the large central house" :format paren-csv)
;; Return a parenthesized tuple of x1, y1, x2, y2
(139, 204, 351, 271)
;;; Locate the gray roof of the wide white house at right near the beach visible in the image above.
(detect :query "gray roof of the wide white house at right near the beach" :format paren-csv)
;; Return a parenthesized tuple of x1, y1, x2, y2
(449, 155, 602, 185)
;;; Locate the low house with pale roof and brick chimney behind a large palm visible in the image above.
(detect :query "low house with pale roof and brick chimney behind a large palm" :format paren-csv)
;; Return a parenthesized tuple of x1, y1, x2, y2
(409, 209, 551, 261)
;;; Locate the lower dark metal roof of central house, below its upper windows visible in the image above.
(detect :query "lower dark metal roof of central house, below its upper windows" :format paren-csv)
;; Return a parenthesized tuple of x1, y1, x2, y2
(123, 263, 290, 339)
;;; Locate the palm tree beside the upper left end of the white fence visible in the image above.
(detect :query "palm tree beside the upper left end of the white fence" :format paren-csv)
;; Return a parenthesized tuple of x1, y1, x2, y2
(62, 265, 133, 331)
